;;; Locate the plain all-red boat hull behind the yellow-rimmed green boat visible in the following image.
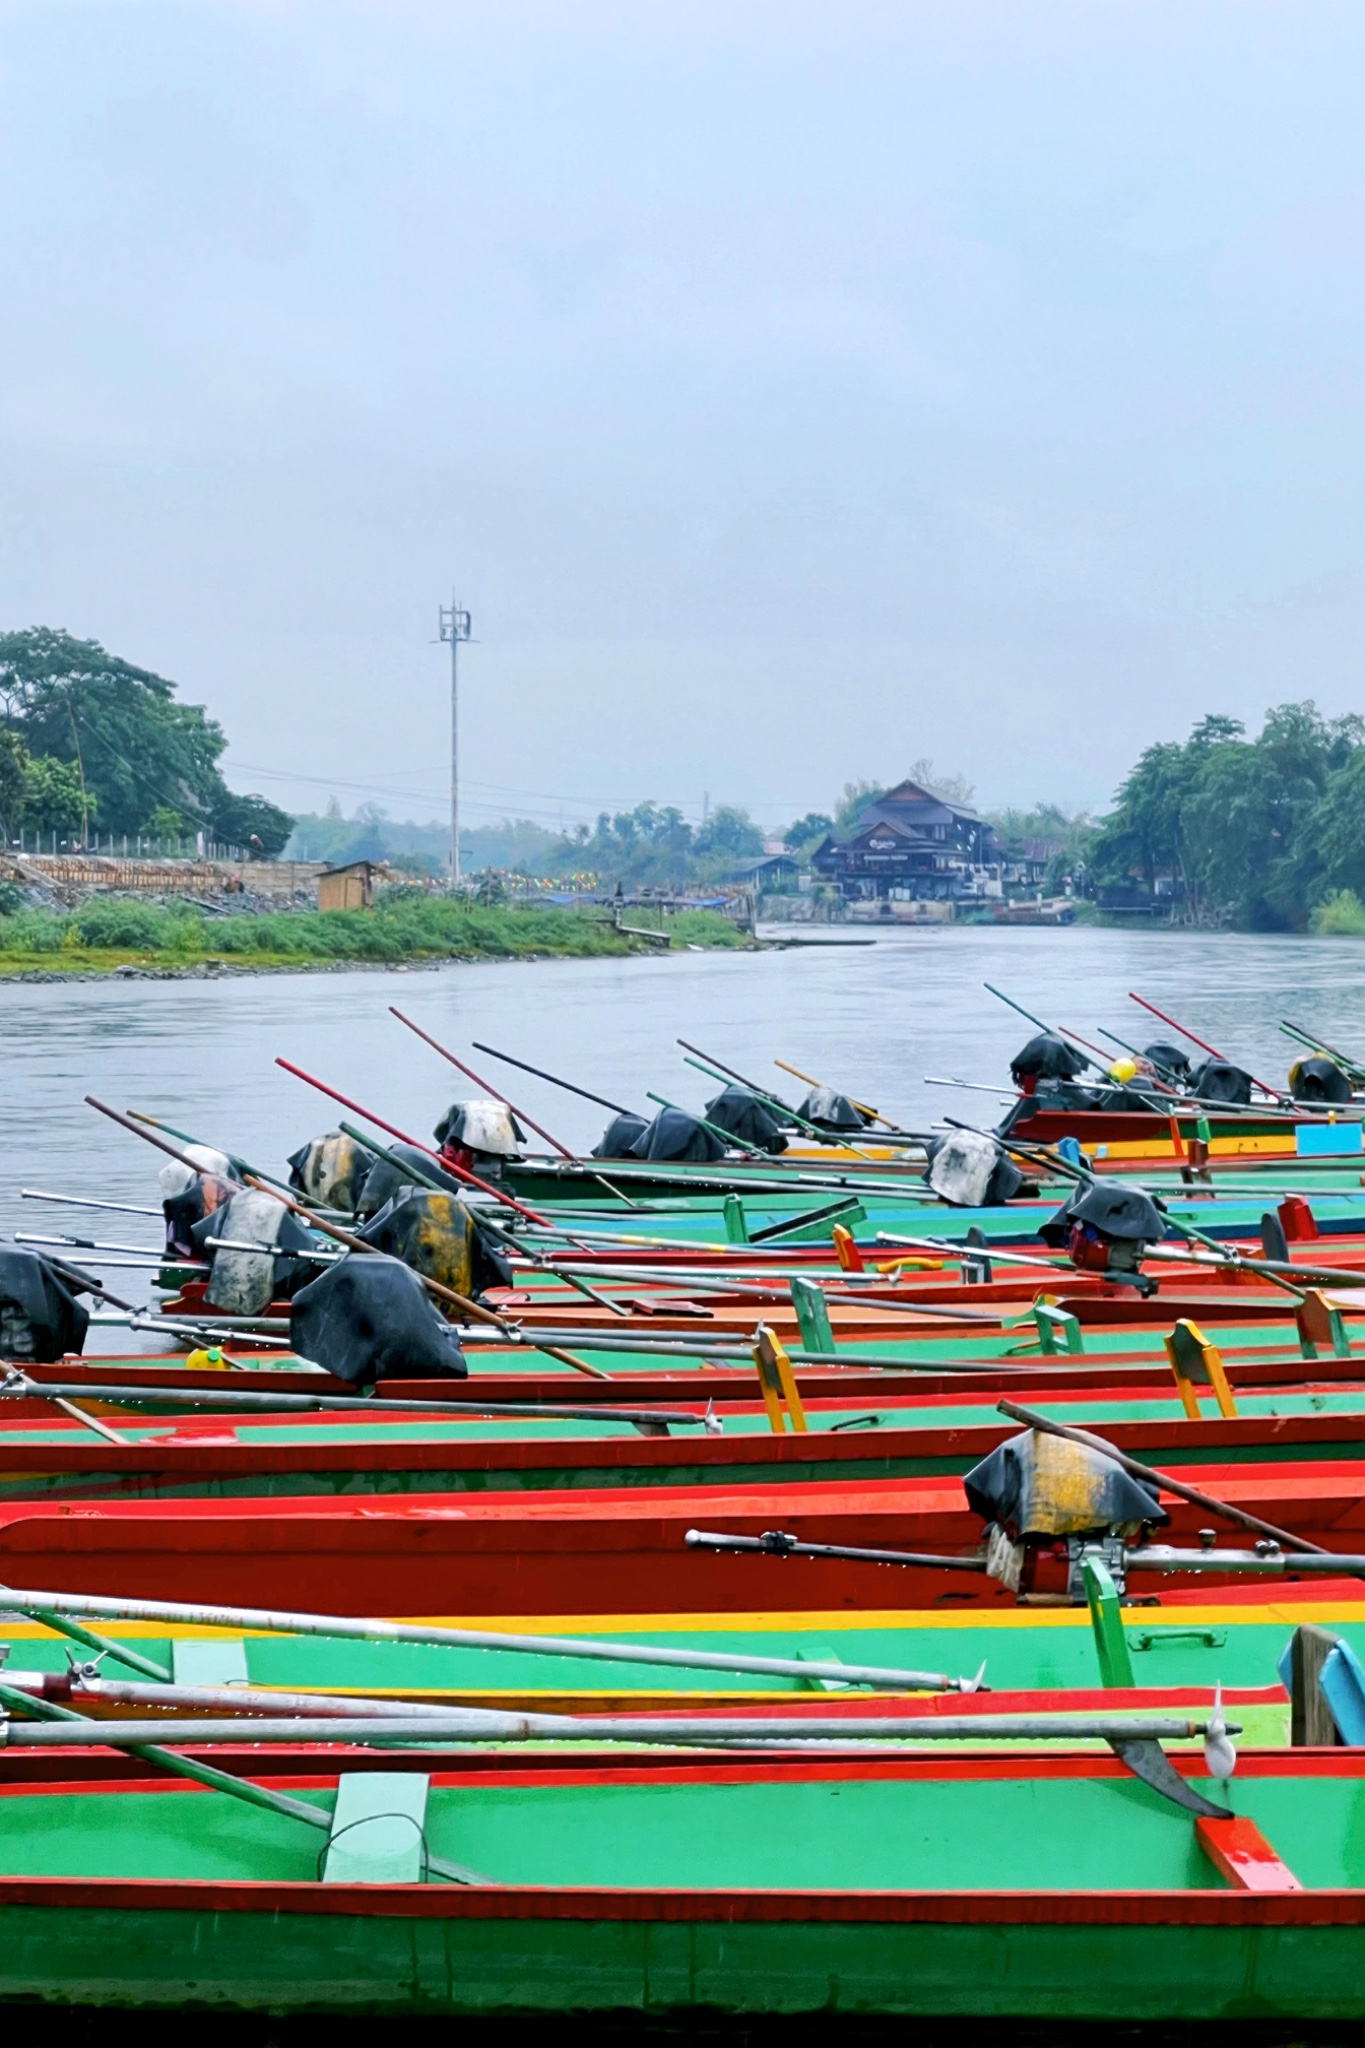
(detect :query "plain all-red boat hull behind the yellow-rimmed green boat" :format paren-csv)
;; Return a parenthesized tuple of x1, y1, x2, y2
(0, 1460, 1365, 1614)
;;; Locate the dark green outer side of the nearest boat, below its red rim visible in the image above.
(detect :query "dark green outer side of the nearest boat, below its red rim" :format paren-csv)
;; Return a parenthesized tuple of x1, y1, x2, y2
(0, 1884, 1365, 2021)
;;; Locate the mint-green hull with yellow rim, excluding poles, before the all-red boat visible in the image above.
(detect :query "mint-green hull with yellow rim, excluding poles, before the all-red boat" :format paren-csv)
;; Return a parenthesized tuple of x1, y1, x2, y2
(0, 1575, 1365, 1703)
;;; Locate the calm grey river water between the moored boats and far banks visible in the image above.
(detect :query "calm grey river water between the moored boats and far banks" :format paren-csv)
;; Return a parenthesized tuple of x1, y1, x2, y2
(0, 928, 1365, 1243)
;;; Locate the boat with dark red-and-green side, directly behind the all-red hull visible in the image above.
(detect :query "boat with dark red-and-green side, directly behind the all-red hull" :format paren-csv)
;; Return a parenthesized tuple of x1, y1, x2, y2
(13, 1382, 1365, 1501)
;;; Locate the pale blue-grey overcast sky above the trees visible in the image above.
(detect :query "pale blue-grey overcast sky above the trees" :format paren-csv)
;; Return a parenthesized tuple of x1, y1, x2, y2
(0, 0, 1365, 825)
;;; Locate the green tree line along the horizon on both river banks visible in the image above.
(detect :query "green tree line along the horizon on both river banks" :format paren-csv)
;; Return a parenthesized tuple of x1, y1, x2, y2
(18, 627, 1365, 932)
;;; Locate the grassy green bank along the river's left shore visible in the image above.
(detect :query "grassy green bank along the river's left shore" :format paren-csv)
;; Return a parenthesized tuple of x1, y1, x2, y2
(0, 897, 745, 977)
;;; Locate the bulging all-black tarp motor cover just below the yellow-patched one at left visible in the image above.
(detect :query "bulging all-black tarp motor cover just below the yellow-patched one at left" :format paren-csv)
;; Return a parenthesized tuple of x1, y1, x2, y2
(289, 1251, 469, 1386)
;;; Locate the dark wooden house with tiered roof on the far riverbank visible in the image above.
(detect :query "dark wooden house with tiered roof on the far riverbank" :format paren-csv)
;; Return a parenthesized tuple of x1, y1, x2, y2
(810, 782, 1007, 903)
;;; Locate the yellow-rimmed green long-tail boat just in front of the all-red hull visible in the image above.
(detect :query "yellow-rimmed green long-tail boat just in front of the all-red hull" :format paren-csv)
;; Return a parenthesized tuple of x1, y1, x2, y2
(0, 1575, 1365, 1703)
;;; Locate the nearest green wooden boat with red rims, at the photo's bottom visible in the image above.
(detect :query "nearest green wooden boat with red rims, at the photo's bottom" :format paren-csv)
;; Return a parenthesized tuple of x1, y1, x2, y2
(0, 1753, 1365, 2023)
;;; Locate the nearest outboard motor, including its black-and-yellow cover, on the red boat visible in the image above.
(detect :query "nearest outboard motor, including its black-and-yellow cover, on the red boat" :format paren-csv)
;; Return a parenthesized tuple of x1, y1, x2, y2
(962, 1430, 1171, 1606)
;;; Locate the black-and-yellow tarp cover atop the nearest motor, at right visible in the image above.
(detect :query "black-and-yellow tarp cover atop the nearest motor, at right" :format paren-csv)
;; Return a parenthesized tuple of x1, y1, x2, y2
(962, 1430, 1171, 1540)
